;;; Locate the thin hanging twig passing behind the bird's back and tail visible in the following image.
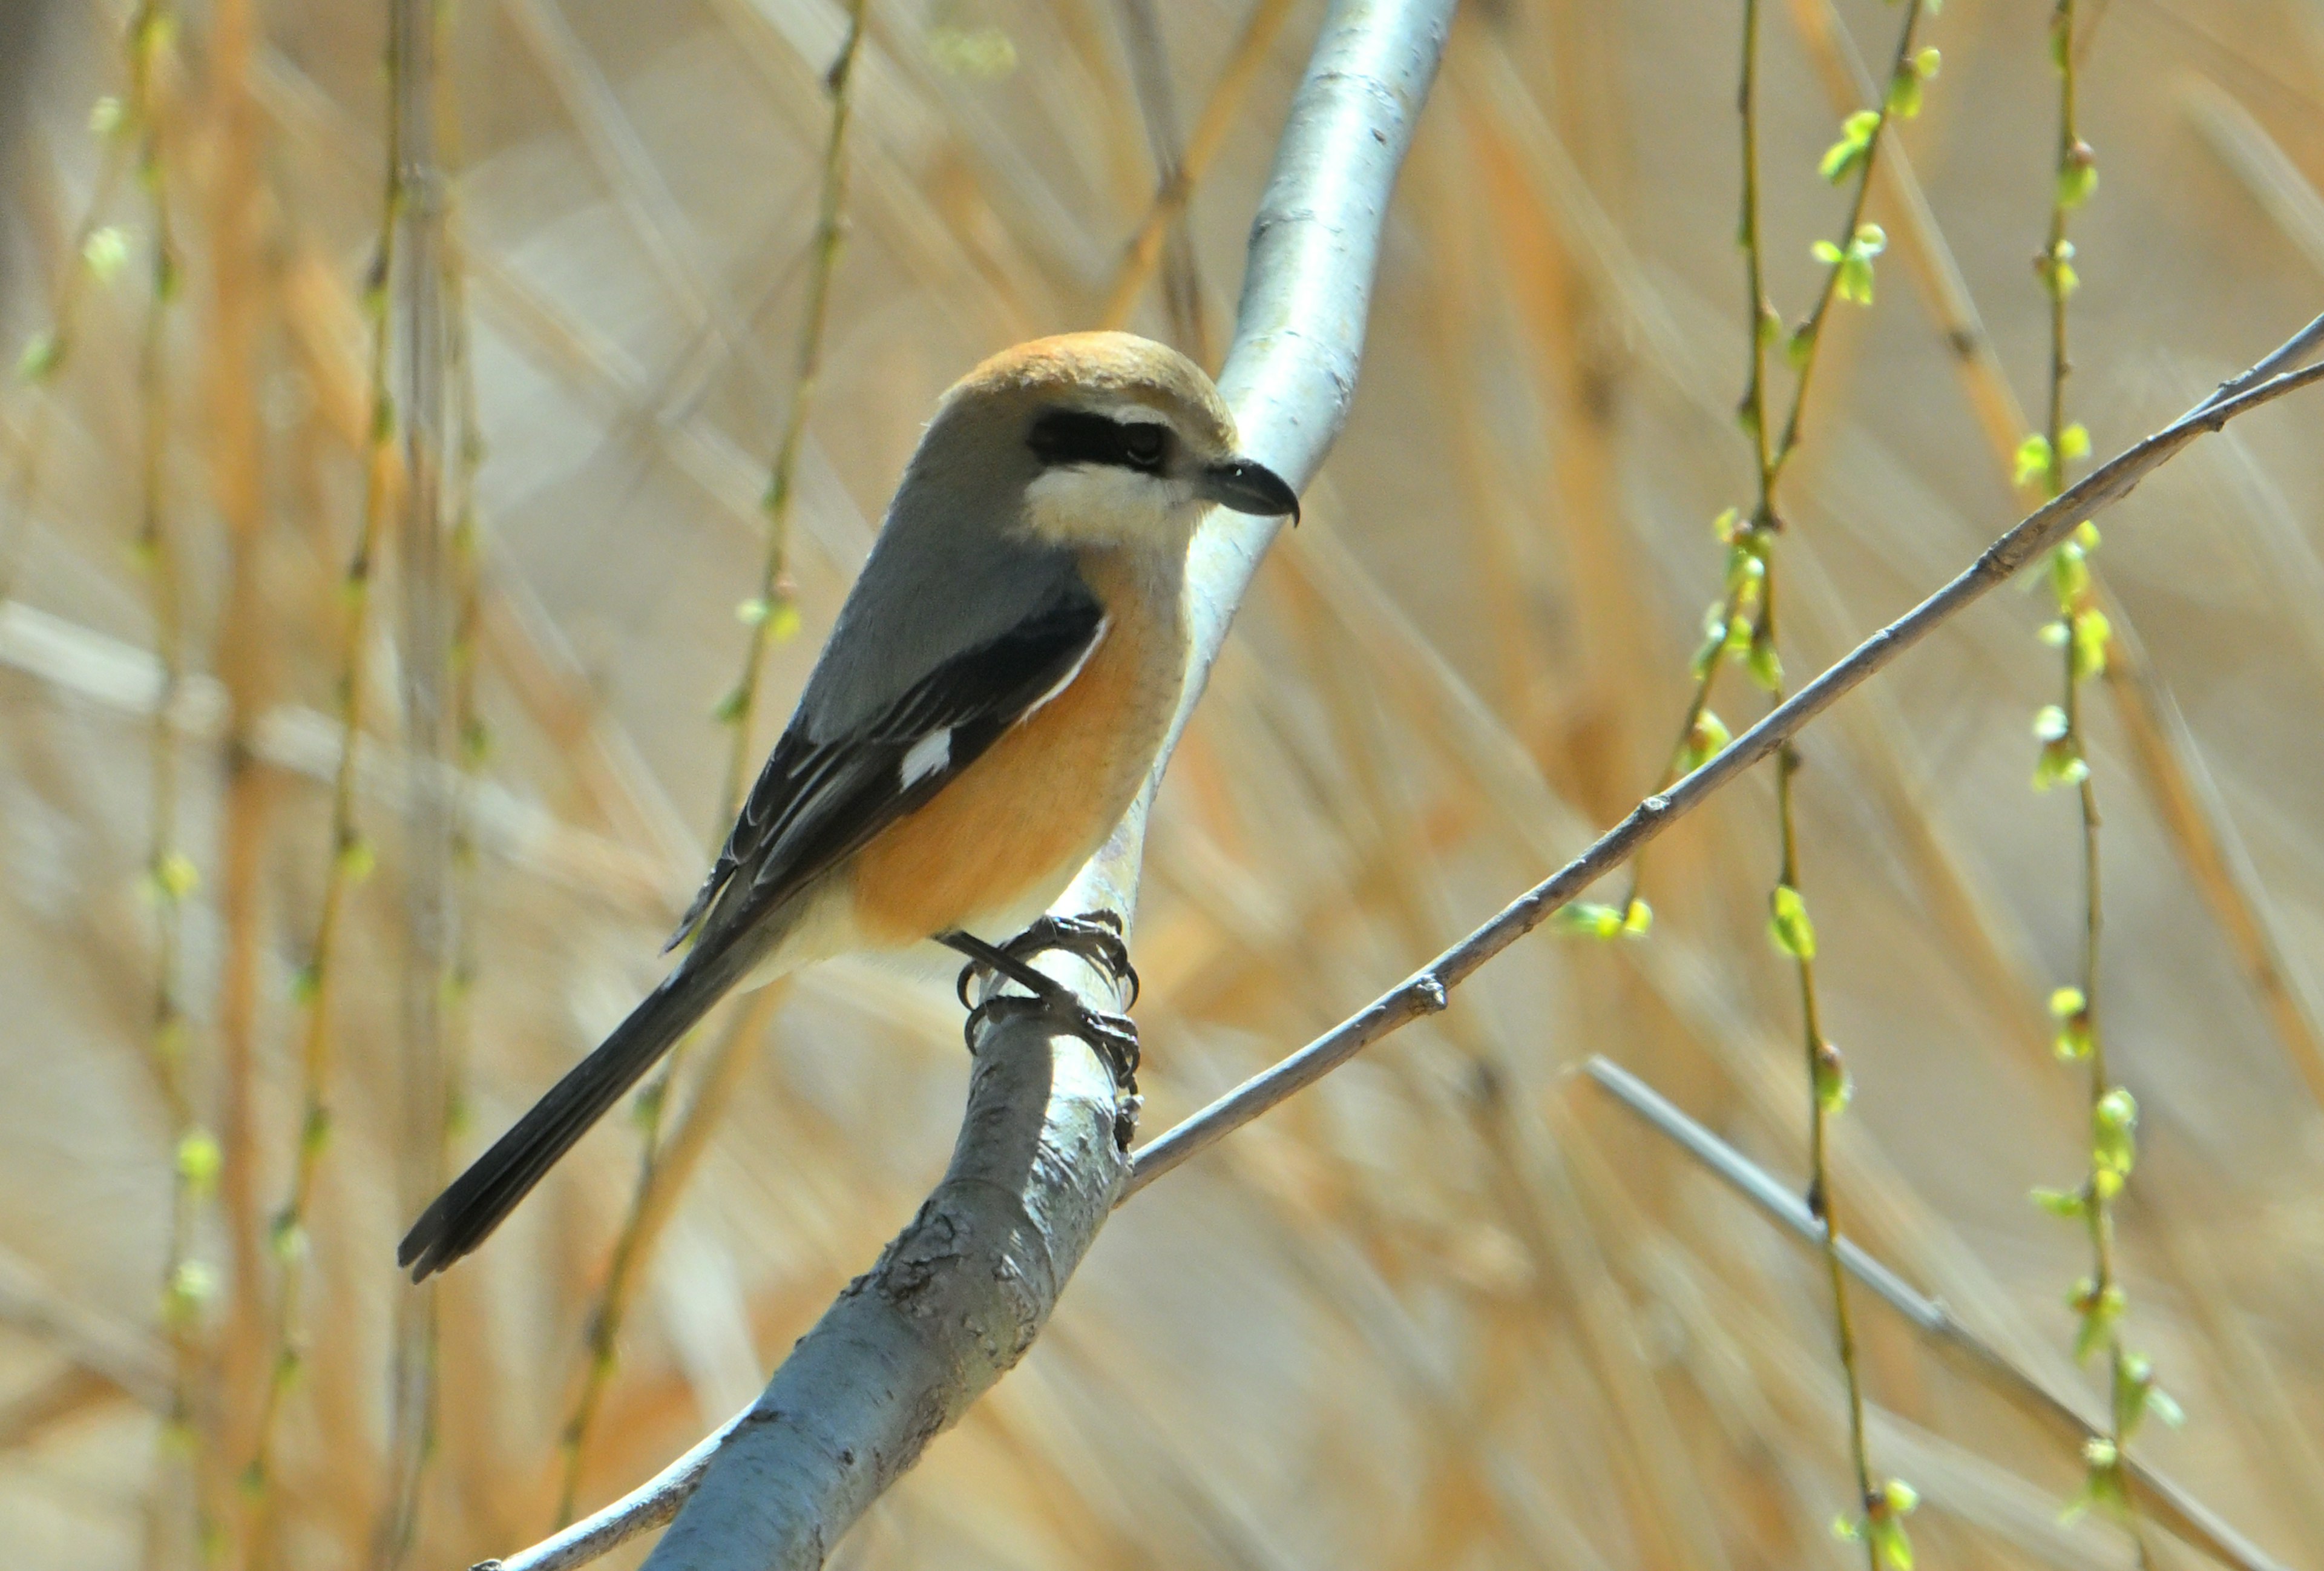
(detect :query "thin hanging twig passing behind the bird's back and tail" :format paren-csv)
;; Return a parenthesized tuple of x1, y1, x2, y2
(558, 0, 864, 1527)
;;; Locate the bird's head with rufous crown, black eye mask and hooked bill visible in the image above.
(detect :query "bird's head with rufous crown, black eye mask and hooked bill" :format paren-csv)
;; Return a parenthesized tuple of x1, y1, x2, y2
(930, 332, 1299, 548)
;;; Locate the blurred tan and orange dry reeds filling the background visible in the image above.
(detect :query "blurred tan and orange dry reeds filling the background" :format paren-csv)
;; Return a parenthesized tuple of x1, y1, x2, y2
(0, 0, 2324, 1571)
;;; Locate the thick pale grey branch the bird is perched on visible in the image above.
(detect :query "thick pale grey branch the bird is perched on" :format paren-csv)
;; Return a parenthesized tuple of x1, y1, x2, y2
(486, 0, 1452, 1571)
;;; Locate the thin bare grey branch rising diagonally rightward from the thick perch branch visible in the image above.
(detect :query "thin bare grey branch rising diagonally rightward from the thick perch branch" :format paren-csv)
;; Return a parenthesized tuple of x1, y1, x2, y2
(1129, 332, 2324, 1194)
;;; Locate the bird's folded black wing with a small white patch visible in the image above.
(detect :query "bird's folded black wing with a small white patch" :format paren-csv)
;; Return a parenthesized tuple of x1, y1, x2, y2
(669, 584, 1106, 948)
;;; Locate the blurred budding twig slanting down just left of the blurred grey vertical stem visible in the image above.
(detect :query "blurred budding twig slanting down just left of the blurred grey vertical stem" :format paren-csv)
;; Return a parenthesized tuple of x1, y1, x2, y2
(241, 28, 409, 1571)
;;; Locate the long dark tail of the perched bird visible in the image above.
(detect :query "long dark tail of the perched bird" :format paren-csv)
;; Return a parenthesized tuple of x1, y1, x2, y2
(395, 944, 750, 1283)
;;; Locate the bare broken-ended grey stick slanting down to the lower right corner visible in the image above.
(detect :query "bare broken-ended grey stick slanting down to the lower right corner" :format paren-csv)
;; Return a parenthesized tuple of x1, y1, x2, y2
(1583, 1055, 2287, 1571)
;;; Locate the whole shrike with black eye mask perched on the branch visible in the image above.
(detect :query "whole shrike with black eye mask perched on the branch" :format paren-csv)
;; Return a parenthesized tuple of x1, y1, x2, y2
(395, 332, 1299, 1283)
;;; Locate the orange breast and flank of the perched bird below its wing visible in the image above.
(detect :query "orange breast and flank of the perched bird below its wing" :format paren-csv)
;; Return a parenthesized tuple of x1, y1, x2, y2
(853, 553, 1185, 948)
